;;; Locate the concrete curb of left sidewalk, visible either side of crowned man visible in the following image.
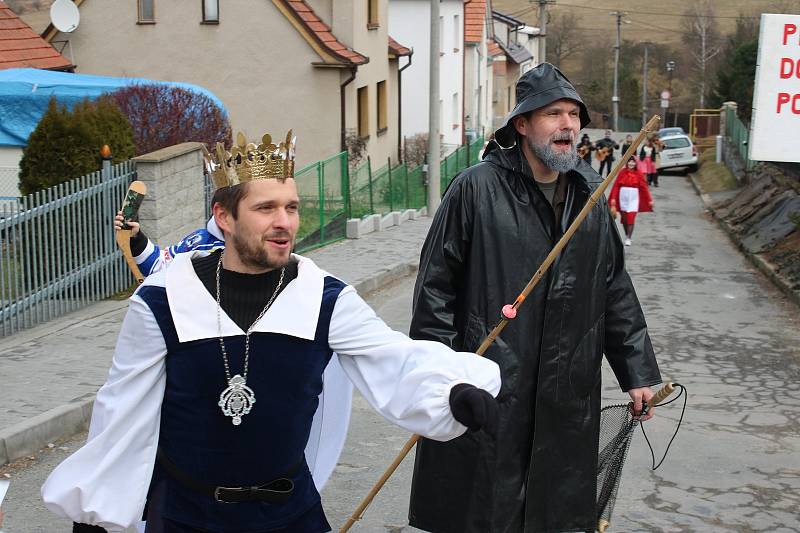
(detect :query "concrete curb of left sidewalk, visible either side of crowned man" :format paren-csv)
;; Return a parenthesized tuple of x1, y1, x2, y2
(0, 262, 417, 466)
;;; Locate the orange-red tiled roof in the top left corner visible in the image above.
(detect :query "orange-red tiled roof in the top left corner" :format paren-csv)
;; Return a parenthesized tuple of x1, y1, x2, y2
(0, 0, 73, 70)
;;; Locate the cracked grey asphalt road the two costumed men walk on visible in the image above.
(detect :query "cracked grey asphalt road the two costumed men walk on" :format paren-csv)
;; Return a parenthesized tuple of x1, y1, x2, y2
(0, 175, 800, 533)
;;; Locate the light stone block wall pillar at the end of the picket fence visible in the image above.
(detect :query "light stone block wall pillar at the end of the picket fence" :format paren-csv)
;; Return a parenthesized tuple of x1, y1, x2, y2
(134, 142, 206, 247)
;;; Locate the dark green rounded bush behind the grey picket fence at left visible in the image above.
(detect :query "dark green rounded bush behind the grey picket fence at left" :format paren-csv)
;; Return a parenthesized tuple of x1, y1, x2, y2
(19, 98, 133, 195)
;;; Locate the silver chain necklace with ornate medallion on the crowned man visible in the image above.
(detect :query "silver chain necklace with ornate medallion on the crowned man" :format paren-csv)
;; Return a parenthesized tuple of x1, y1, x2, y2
(217, 252, 286, 426)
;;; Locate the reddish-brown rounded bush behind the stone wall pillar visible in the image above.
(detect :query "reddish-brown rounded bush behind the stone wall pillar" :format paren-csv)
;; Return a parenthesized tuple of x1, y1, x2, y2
(110, 85, 232, 155)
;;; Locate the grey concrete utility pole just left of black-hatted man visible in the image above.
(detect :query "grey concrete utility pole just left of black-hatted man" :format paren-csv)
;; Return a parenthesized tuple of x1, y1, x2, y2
(428, 0, 442, 217)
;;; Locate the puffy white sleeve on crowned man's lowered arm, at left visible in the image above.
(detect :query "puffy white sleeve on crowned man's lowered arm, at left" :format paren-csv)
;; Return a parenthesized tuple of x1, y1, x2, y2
(42, 295, 167, 532)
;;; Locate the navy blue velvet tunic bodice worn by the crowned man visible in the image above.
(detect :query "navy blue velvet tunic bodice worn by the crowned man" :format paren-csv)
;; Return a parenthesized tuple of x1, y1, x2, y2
(138, 276, 345, 533)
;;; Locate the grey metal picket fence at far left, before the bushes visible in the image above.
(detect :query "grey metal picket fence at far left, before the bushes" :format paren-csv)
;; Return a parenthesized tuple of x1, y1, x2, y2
(0, 161, 135, 336)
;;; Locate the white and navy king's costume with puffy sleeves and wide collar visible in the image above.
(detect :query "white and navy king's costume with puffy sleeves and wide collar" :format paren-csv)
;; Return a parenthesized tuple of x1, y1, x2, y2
(42, 252, 500, 531)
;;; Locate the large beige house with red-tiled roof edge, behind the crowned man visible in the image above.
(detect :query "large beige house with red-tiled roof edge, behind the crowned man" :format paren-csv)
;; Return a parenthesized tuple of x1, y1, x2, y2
(42, 0, 411, 166)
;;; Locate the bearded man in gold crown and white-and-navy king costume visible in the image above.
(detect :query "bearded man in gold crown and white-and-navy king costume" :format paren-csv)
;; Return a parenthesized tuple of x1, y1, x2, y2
(42, 132, 500, 533)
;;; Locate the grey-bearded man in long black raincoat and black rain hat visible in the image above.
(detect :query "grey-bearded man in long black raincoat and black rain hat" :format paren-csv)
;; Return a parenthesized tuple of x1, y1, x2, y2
(409, 63, 661, 533)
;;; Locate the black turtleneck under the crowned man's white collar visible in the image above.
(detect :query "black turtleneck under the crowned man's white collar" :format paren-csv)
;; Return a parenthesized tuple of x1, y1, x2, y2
(192, 251, 297, 332)
